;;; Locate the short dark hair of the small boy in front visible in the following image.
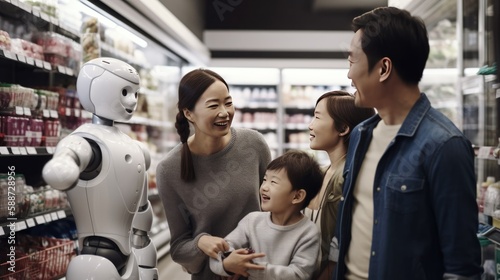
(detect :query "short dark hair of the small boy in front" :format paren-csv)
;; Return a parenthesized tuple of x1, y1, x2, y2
(267, 150, 323, 209)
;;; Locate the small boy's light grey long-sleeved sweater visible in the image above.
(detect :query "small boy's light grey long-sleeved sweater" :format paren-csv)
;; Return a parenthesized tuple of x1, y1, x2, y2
(210, 212, 320, 280)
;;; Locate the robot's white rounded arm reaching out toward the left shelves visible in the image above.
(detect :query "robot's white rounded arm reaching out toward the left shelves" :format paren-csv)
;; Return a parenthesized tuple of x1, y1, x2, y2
(42, 135, 93, 190)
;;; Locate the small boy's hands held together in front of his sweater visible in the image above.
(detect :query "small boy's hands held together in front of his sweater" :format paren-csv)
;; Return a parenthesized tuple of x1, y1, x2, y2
(222, 249, 266, 277)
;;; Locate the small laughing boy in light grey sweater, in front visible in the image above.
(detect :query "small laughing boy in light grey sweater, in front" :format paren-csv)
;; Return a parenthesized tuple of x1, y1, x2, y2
(210, 150, 323, 279)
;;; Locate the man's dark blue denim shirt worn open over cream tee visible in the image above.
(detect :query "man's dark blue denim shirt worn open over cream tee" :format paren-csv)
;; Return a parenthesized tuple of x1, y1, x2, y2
(336, 93, 482, 280)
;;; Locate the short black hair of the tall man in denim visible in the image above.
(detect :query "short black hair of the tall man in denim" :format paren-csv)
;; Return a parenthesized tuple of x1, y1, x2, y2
(352, 7, 429, 85)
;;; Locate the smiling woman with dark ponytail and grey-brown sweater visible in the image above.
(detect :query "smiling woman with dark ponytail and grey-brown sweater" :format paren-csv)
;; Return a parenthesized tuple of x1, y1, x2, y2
(156, 69, 271, 279)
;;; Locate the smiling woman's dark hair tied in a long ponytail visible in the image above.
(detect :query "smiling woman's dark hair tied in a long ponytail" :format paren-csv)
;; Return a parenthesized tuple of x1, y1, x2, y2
(175, 69, 229, 182)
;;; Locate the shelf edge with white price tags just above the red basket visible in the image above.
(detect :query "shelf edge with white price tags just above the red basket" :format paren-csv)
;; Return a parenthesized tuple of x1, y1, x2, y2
(0, 209, 71, 236)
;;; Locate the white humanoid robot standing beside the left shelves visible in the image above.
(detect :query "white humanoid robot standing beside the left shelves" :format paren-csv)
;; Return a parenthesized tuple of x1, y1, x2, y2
(42, 58, 158, 280)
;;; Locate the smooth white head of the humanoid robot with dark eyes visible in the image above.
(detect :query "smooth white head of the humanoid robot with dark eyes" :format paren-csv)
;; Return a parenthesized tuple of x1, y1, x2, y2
(76, 57, 140, 121)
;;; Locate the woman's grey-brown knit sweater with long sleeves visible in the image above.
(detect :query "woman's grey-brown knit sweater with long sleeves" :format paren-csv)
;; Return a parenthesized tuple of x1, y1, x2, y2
(156, 128, 271, 280)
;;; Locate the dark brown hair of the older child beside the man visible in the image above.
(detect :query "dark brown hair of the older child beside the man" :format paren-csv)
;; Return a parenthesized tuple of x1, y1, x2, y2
(316, 90, 375, 148)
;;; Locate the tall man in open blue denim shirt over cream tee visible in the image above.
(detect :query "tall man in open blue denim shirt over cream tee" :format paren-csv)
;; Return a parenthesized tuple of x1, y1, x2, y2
(335, 7, 482, 280)
